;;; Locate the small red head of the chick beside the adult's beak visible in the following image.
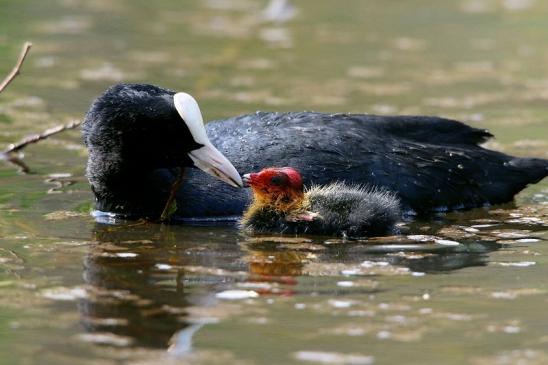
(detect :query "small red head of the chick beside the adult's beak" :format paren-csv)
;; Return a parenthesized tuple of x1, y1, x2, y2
(243, 167, 304, 212)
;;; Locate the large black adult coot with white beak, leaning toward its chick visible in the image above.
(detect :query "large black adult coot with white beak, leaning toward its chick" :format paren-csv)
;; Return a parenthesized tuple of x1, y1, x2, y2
(83, 84, 548, 218)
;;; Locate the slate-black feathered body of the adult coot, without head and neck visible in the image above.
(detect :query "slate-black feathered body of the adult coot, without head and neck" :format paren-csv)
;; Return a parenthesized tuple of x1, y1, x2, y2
(177, 112, 548, 216)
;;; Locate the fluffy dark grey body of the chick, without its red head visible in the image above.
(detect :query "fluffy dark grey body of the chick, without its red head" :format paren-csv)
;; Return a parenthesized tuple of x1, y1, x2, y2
(240, 182, 401, 237)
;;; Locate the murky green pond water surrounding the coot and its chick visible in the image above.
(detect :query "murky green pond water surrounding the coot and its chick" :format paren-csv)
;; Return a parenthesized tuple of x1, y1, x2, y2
(0, 0, 548, 365)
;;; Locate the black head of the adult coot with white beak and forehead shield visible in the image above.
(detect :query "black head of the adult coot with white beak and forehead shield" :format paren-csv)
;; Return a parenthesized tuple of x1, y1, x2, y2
(83, 84, 243, 187)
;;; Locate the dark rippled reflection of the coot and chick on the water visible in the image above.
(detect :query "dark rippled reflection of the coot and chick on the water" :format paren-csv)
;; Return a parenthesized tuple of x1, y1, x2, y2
(79, 205, 545, 355)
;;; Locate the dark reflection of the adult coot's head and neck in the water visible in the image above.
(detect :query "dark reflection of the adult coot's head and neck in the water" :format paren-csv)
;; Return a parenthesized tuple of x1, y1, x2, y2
(80, 224, 203, 348)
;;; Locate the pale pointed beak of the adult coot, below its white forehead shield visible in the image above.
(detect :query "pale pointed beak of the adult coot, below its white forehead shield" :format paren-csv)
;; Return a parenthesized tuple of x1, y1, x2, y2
(188, 143, 244, 188)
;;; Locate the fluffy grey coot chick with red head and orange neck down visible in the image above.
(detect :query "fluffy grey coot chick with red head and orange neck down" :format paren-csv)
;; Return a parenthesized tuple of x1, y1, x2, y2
(240, 167, 401, 237)
